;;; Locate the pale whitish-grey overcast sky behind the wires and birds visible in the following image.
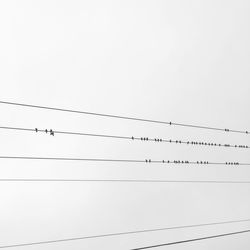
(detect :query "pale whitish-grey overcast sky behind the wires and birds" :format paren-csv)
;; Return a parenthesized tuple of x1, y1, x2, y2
(0, 0, 250, 250)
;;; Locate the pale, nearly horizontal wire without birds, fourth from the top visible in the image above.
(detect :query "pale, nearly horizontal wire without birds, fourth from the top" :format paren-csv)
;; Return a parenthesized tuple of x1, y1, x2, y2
(0, 178, 250, 184)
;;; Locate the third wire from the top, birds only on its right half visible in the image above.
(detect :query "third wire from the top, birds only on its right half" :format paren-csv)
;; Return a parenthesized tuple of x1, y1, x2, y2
(0, 156, 246, 166)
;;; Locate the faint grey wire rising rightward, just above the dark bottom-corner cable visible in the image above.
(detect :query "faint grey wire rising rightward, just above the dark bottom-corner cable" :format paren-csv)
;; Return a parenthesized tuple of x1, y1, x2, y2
(0, 219, 250, 249)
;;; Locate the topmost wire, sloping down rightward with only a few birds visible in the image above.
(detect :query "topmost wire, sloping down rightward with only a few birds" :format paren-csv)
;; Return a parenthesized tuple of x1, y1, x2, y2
(0, 101, 250, 134)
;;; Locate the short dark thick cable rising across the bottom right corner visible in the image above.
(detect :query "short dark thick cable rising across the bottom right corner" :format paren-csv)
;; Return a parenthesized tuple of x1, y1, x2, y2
(130, 230, 250, 250)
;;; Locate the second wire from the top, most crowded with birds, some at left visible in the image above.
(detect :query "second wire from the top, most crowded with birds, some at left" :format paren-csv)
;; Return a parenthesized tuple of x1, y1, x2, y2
(0, 126, 249, 148)
